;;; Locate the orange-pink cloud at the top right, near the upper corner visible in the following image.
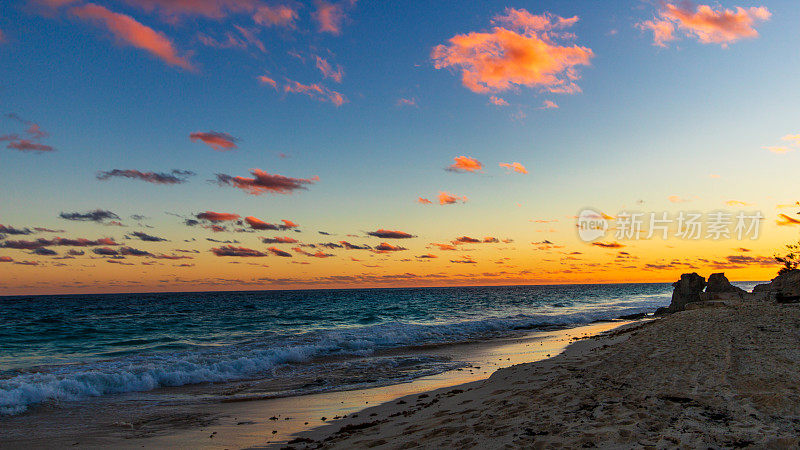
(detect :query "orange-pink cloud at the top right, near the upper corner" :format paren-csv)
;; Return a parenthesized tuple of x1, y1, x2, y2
(637, 3, 772, 47)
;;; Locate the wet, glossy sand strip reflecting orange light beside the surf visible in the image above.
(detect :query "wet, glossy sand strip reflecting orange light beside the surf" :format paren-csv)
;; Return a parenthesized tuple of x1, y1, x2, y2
(2, 321, 630, 448)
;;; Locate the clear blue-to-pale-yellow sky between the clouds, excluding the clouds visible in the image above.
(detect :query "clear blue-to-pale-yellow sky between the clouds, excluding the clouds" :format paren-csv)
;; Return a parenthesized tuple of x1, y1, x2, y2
(0, 0, 800, 294)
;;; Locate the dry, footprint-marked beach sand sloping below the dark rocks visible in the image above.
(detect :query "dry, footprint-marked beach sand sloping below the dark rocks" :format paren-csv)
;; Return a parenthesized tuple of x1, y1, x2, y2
(291, 302, 800, 449)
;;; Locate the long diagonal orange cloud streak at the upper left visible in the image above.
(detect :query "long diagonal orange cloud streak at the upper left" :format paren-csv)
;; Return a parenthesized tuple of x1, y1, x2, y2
(70, 3, 195, 70)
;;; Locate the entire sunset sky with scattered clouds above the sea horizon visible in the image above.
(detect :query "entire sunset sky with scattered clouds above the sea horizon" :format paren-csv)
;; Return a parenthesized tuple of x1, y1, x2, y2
(0, 0, 800, 295)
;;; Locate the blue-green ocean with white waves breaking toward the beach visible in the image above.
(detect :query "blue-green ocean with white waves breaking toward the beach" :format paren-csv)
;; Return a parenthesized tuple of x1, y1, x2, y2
(0, 283, 755, 415)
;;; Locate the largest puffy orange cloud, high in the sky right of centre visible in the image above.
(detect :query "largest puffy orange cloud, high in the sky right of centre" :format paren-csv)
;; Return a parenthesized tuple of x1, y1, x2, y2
(431, 9, 594, 93)
